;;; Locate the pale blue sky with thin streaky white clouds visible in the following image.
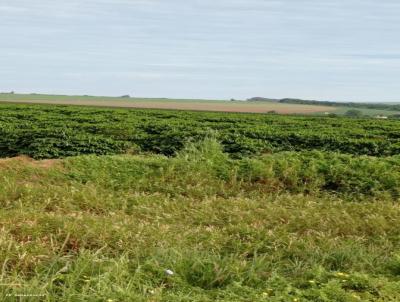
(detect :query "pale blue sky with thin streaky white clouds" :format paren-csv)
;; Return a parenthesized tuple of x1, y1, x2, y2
(0, 0, 400, 102)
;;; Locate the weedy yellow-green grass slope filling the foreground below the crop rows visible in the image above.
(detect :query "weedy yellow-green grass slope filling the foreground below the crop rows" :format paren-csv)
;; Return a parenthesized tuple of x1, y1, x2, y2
(0, 140, 400, 301)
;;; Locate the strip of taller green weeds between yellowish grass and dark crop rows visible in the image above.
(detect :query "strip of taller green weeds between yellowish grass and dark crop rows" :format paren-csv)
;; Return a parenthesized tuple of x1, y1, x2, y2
(59, 138, 400, 201)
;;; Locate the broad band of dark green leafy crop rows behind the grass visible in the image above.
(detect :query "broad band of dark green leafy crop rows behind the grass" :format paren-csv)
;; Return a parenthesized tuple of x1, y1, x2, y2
(0, 104, 400, 159)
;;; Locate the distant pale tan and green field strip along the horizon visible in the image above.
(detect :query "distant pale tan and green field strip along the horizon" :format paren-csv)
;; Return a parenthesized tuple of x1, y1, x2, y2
(0, 93, 400, 117)
